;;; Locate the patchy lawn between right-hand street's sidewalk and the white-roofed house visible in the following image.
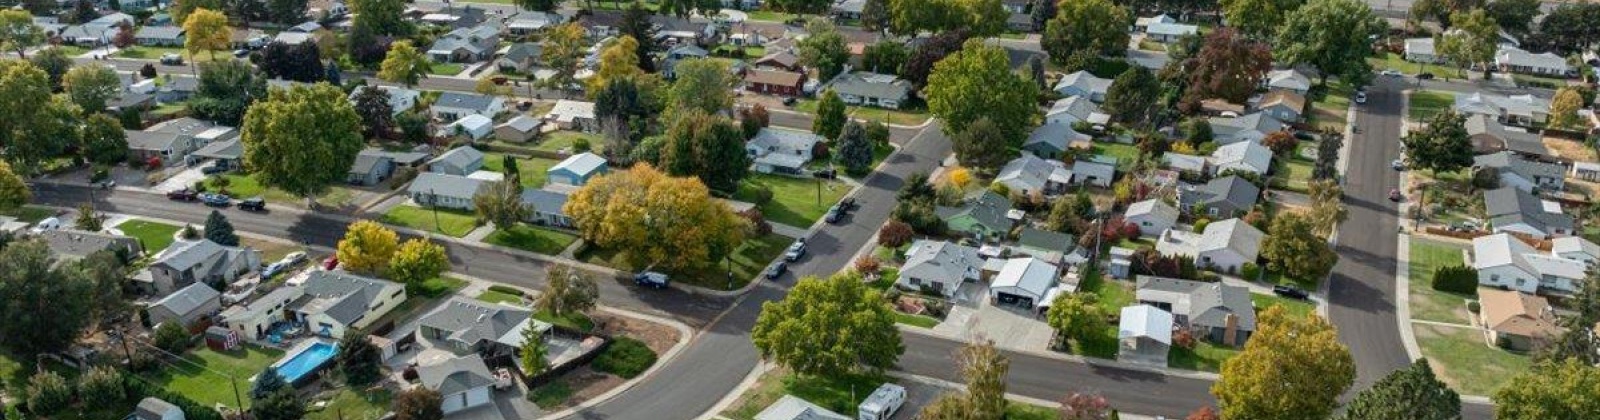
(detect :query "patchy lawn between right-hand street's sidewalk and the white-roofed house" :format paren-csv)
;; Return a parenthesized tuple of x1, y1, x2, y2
(1406, 239, 1472, 324)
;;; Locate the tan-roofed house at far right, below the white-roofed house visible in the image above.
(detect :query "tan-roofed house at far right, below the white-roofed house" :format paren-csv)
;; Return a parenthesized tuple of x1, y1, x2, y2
(1478, 287, 1562, 351)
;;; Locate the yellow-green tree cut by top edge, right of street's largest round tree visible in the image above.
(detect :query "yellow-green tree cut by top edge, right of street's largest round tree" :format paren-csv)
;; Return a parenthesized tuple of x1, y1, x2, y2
(1038, 0, 1133, 64)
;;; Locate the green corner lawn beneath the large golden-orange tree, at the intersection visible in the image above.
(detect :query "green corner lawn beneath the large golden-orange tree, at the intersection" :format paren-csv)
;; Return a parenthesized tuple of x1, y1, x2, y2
(576, 234, 794, 290)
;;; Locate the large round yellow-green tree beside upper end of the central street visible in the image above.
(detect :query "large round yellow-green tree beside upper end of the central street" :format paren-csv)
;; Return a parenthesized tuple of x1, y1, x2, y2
(923, 40, 1036, 146)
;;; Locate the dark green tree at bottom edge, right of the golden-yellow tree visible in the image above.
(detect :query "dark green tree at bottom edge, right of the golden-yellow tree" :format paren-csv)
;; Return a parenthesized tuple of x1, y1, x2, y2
(1339, 359, 1461, 420)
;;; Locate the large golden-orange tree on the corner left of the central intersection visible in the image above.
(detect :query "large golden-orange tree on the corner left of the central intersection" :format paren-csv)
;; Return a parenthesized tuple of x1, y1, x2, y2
(563, 164, 746, 271)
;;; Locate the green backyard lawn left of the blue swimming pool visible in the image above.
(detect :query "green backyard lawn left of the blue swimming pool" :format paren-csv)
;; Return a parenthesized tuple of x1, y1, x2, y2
(146, 346, 283, 407)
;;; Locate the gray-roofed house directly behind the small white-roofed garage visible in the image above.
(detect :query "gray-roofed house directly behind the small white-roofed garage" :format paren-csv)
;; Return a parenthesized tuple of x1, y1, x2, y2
(1136, 276, 1256, 348)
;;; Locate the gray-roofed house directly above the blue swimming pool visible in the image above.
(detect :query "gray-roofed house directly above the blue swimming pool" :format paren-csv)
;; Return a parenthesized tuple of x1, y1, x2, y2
(288, 269, 405, 338)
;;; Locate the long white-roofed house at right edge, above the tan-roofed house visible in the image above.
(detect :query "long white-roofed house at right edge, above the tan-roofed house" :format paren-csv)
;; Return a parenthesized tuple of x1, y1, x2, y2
(1470, 234, 1600, 295)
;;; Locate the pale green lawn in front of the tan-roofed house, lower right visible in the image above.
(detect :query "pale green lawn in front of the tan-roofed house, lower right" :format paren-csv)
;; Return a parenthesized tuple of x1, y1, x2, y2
(1413, 324, 1531, 396)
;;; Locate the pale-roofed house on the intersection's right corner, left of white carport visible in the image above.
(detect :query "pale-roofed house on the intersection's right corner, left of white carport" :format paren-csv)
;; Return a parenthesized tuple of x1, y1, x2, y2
(894, 239, 984, 297)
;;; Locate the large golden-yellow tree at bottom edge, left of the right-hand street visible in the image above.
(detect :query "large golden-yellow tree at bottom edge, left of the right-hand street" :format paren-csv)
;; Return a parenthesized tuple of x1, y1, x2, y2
(1211, 304, 1355, 420)
